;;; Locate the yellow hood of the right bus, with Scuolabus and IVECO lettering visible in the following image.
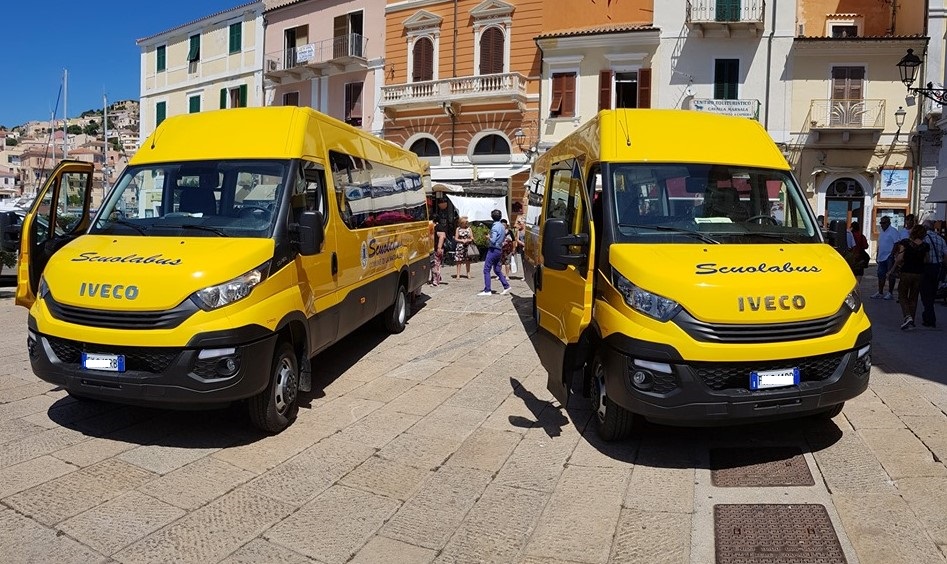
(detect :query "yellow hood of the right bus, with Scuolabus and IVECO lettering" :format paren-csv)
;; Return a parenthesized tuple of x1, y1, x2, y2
(609, 244, 855, 323)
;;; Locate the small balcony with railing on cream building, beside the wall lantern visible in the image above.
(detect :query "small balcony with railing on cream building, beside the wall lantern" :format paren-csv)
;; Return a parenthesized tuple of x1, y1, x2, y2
(809, 100, 885, 144)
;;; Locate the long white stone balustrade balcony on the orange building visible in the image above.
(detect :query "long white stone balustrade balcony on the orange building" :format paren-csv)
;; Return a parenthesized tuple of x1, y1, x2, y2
(378, 73, 526, 114)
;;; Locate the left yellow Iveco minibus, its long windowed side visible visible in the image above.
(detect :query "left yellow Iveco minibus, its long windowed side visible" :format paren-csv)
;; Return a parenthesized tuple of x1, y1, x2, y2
(16, 107, 432, 432)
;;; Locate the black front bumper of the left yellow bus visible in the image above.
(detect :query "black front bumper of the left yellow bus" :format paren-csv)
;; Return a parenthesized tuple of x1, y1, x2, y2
(27, 317, 276, 408)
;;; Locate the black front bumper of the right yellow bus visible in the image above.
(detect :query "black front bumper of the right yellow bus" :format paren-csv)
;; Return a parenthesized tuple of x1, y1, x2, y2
(601, 329, 871, 426)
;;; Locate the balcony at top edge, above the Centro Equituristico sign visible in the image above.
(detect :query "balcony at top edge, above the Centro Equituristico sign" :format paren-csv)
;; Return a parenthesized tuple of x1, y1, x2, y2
(685, 0, 766, 37)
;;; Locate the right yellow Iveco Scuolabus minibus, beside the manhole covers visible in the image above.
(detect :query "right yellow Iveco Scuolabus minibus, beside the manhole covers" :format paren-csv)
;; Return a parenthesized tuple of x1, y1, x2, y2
(524, 109, 871, 440)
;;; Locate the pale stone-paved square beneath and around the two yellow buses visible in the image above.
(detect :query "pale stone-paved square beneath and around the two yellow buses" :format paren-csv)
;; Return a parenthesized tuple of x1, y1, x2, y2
(0, 267, 947, 564)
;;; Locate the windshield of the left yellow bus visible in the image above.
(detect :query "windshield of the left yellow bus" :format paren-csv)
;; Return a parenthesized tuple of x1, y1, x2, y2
(89, 160, 290, 237)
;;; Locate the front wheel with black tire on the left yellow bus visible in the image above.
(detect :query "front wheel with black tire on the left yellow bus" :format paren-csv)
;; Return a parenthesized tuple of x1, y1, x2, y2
(247, 341, 299, 433)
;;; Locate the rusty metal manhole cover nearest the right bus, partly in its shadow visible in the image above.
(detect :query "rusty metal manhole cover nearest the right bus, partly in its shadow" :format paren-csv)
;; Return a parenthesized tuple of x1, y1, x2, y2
(710, 446, 815, 488)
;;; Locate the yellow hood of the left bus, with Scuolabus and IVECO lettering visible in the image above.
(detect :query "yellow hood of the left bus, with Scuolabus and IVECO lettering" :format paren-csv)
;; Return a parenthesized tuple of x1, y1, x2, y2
(43, 235, 273, 311)
